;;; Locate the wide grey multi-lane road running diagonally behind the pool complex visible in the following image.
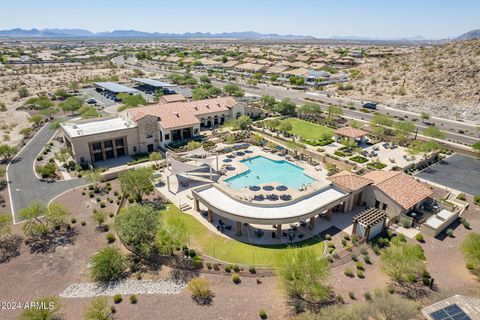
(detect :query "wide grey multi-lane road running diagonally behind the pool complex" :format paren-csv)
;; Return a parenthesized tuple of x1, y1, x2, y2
(112, 57, 479, 149)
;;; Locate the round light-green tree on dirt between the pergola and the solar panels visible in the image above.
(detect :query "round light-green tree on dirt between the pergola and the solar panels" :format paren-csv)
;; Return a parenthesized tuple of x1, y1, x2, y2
(381, 241, 426, 285)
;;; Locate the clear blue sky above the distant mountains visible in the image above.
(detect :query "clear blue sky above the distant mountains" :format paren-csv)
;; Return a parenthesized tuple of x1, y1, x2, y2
(0, 0, 480, 38)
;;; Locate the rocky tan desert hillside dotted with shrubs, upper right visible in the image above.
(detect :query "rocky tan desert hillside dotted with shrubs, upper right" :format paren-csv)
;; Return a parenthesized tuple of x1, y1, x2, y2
(337, 39, 480, 121)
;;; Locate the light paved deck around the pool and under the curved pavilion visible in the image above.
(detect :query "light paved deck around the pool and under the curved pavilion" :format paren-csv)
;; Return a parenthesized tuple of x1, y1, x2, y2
(156, 146, 361, 245)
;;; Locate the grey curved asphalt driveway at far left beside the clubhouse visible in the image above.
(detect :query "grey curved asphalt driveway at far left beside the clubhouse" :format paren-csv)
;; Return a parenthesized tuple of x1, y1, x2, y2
(7, 124, 85, 223)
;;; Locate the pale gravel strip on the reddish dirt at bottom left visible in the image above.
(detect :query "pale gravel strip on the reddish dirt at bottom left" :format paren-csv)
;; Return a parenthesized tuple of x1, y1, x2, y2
(60, 280, 185, 298)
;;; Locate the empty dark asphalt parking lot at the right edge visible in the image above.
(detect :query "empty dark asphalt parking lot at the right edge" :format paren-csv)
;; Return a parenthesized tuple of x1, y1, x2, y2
(416, 154, 480, 195)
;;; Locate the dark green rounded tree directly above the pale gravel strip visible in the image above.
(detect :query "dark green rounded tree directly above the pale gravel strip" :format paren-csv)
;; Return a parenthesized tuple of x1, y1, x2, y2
(90, 247, 127, 282)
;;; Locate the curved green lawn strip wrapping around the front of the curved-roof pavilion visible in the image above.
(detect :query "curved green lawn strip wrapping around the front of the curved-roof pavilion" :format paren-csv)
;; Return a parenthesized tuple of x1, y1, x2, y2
(162, 204, 324, 267)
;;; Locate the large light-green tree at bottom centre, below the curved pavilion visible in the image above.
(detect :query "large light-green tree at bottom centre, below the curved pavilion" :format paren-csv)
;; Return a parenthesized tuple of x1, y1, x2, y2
(277, 247, 332, 309)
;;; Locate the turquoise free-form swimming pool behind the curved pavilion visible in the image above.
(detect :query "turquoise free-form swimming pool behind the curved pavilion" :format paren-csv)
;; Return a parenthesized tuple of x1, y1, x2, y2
(225, 156, 316, 189)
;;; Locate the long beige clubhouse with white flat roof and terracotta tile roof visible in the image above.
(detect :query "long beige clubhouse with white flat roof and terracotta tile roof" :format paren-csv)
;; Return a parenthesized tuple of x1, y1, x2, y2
(61, 97, 259, 164)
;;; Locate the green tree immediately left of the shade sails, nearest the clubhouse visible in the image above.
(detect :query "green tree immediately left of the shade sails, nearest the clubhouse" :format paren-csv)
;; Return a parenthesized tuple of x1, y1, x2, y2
(119, 167, 153, 201)
